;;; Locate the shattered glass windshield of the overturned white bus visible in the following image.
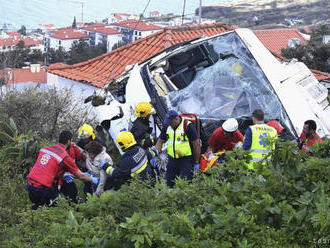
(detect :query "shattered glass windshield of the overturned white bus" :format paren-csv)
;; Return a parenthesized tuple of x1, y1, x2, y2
(164, 32, 291, 137)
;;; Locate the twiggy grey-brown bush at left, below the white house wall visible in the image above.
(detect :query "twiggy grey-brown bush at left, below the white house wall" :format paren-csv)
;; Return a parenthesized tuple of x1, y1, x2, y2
(0, 87, 94, 141)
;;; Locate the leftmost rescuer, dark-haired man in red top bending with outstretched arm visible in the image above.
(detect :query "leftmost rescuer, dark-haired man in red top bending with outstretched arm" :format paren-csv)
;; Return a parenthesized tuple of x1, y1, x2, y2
(26, 131, 98, 210)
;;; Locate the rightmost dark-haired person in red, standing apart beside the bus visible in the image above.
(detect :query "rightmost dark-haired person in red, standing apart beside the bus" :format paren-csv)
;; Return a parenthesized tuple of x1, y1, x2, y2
(298, 120, 322, 153)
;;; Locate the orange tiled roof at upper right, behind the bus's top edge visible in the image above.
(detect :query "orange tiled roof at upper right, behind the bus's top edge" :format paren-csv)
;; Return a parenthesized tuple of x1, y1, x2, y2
(253, 28, 307, 55)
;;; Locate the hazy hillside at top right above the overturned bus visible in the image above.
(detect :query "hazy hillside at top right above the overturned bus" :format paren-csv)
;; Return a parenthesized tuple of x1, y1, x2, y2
(200, 0, 330, 27)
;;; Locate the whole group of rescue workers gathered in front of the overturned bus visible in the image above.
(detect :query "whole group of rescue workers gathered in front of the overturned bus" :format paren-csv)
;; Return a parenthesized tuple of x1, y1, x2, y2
(26, 102, 322, 209)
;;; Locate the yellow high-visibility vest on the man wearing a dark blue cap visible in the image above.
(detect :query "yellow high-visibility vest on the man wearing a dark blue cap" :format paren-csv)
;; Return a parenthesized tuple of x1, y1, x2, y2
(166, 117, 192, 158)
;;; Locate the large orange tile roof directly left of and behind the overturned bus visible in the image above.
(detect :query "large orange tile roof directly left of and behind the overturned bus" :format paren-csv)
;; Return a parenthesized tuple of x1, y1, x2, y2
(48, 23, 232, 88)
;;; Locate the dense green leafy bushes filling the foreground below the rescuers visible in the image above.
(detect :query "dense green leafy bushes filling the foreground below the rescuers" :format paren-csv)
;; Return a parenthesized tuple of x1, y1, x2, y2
(0, 141, 330, 248)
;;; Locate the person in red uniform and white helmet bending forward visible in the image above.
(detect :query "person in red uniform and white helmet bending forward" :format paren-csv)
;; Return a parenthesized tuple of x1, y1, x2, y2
(208, 118, 243, 153)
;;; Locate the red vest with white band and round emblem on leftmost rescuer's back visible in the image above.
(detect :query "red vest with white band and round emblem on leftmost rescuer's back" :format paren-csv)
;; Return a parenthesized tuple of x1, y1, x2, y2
(27, 144, 69, 188)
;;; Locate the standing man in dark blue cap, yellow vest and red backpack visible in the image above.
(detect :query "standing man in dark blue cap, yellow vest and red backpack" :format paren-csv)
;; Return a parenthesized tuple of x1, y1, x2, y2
(155, 110, 201, 187)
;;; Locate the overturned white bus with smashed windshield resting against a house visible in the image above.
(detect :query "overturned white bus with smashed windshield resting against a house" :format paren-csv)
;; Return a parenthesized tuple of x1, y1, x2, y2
(87, 29, 330, 148)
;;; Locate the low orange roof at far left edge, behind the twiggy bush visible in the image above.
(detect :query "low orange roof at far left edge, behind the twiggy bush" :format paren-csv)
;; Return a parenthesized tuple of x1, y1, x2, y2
(1, 68, 46, 84)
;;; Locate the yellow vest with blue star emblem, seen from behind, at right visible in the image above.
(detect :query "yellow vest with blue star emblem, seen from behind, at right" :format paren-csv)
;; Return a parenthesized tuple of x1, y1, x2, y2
(248, 123, 277, 169)
